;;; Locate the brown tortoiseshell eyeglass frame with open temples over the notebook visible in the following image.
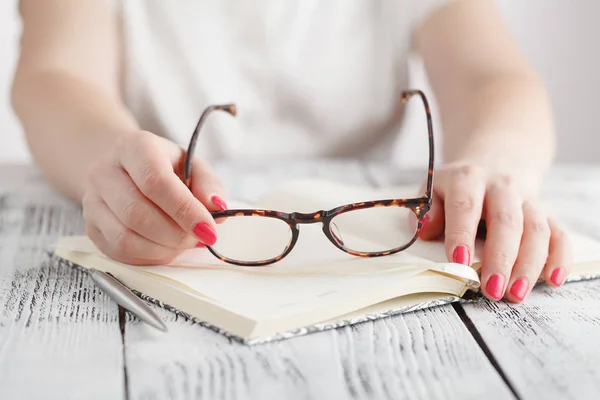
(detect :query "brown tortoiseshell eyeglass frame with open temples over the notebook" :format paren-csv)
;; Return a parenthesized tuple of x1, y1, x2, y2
(183, 90, 434, 267)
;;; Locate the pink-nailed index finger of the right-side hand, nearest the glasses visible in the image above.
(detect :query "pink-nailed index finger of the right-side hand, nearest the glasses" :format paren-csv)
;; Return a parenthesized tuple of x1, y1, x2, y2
(444, 169, 485, 265)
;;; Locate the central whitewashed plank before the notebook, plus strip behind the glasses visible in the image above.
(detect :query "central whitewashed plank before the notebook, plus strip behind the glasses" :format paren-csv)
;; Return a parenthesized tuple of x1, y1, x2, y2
(124, 163, 514, 399)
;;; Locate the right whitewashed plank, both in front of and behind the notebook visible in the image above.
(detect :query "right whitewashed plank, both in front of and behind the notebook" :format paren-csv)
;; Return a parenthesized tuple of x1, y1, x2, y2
(464, 167, 600, 399)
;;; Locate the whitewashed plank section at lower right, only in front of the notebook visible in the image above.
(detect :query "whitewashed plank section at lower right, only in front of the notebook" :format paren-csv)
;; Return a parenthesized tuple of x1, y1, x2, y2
(465, 281, 600, 399)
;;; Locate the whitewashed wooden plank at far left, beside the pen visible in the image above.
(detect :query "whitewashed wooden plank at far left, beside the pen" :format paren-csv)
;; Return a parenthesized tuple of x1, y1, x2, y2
(0, 166, 125, 399)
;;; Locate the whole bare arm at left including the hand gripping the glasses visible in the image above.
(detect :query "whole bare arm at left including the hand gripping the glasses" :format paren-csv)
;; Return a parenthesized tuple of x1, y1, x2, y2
(12, 0, 226, 265)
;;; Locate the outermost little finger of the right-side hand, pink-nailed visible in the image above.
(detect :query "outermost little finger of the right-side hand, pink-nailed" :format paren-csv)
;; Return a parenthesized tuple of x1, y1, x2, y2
(506, 202, 550, 303)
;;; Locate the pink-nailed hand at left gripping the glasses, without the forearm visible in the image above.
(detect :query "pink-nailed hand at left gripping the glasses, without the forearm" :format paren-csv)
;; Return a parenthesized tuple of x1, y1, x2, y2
(82, 131, 227, 265)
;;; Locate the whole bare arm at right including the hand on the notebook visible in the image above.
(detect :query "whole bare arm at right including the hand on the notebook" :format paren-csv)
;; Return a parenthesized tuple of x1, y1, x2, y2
(415, 0, 572, 302)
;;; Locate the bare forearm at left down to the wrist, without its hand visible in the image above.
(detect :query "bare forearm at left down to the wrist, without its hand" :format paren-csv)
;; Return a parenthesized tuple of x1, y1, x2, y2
(12, 0, 137, 201)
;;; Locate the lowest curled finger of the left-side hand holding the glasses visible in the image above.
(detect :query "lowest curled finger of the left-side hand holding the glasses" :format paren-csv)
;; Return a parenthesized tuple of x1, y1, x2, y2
(85, 197, 179, 265)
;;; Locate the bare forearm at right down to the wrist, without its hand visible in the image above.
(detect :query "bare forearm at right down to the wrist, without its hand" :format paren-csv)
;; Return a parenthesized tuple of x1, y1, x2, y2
(416, 0, 555, 195)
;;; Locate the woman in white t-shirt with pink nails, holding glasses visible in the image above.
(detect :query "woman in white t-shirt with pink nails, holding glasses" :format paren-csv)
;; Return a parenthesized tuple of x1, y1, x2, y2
(13, 0, 571, 302)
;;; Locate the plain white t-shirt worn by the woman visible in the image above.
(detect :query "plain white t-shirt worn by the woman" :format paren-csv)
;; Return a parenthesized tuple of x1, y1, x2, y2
(115, 0, 447, 161)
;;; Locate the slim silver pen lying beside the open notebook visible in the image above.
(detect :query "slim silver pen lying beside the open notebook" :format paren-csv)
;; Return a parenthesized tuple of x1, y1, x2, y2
(89, 268, 167, 332)
